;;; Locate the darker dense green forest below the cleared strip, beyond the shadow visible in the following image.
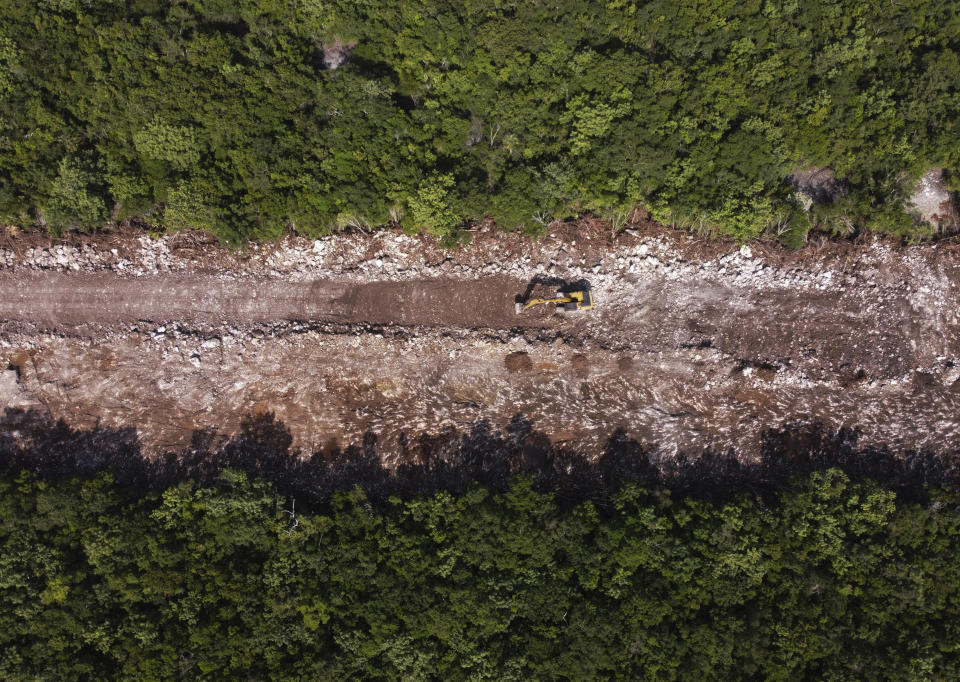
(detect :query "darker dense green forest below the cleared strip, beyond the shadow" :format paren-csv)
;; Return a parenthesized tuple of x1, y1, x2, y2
(0, 470, 960, 680)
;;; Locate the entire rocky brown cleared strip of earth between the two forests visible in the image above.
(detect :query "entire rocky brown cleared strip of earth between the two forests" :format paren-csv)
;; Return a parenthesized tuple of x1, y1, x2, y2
(0, 221, 960, 467)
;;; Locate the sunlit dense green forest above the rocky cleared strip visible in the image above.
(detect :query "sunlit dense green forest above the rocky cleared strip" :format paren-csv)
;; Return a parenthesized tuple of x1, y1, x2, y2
(0, 0, 960, 243)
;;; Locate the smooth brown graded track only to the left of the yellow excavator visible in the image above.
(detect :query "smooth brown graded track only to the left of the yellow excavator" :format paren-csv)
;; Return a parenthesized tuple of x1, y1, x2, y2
(0, 272, 544, 329)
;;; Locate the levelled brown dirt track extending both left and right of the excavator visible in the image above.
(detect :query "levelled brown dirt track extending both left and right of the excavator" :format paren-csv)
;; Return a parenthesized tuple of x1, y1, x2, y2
(0, 272, 944, 378)
